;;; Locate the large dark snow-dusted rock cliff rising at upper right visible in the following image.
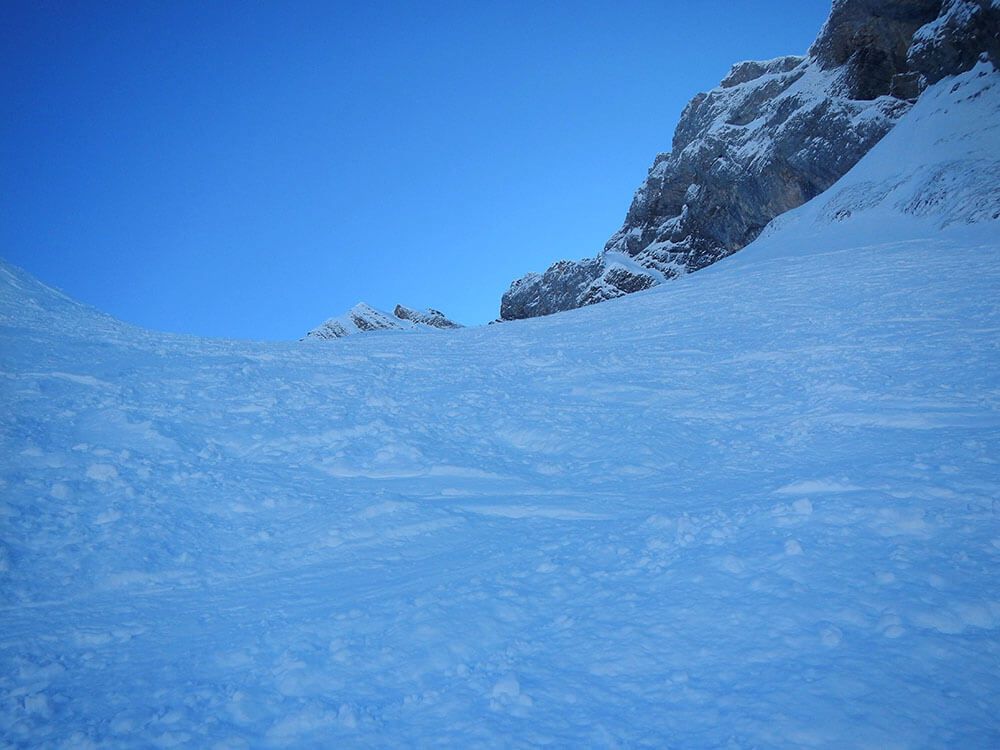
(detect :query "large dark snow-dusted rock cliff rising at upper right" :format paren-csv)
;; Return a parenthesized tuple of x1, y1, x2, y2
(500, 0, 1000, 320)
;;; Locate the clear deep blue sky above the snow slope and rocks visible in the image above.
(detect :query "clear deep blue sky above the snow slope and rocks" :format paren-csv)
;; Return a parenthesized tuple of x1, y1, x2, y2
(0, 0, 829, 339)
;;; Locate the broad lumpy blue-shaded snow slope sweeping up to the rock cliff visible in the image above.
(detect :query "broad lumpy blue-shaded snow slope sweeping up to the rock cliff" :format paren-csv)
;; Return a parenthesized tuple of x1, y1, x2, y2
(0, 68, 1000, 748)
